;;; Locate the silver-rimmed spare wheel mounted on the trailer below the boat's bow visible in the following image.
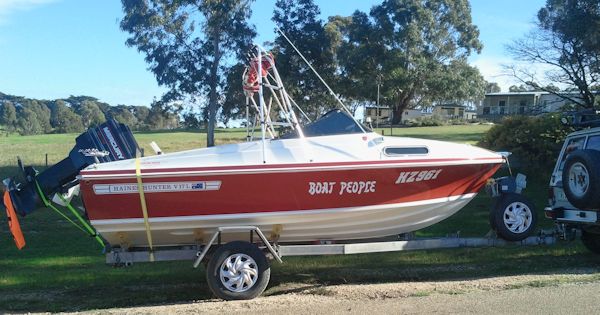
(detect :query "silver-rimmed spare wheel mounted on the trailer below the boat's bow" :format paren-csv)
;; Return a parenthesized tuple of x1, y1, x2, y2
(492, 193, 537, 242)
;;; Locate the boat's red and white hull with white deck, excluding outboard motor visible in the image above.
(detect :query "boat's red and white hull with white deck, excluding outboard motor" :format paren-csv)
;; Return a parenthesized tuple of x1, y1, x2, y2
(80, 126, 503, 246)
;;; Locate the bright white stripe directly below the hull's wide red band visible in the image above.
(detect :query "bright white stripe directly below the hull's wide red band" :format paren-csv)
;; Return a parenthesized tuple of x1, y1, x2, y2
(90, 193, 477, 227)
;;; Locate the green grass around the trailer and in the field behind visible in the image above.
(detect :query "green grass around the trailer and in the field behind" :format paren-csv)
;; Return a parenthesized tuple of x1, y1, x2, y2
(0, 126, 600, 313)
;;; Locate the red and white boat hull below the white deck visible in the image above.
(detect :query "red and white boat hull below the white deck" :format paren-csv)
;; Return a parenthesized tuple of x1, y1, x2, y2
(80, 160, 500, 247)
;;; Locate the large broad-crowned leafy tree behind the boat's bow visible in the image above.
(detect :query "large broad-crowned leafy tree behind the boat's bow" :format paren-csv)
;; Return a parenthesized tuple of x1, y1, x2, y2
(330, 0, 485, 123)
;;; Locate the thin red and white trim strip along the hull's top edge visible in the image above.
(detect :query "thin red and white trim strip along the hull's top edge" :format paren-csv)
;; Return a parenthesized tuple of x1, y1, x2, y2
(80, 157, 504, 179)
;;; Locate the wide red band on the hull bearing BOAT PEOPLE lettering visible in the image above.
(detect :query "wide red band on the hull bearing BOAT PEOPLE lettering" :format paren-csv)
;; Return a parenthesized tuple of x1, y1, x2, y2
(81, 163, 500, 220)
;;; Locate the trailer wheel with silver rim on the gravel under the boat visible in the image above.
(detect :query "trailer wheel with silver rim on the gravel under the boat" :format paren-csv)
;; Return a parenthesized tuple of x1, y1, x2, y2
(206, 241, 271, 300)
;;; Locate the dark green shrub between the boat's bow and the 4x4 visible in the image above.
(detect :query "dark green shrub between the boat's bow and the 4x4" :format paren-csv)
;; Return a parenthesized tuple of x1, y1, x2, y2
(479, 114, 573, 173)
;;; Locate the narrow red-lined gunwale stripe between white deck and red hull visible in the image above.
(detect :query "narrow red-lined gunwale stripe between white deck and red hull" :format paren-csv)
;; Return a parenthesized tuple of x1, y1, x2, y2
(81, 157, 503, 179)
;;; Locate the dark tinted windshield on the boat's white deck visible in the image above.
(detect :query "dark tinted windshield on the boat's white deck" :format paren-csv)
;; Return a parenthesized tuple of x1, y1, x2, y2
(280, 109, 371, 139)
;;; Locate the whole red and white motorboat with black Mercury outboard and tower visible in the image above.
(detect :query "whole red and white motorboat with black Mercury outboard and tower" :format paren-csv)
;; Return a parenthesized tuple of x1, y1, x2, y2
(4, 48, 505, 252)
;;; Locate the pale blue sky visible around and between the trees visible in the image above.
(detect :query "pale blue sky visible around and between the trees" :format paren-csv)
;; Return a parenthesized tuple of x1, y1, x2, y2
(0, 0, 545, 105)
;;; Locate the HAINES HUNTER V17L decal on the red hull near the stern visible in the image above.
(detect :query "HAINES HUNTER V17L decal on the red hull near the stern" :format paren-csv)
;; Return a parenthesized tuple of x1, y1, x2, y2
(94, 181, 221, 195)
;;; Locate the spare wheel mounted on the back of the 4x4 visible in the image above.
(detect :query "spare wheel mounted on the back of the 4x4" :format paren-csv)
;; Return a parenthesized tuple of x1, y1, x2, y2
(562, 150, 600, 209)
